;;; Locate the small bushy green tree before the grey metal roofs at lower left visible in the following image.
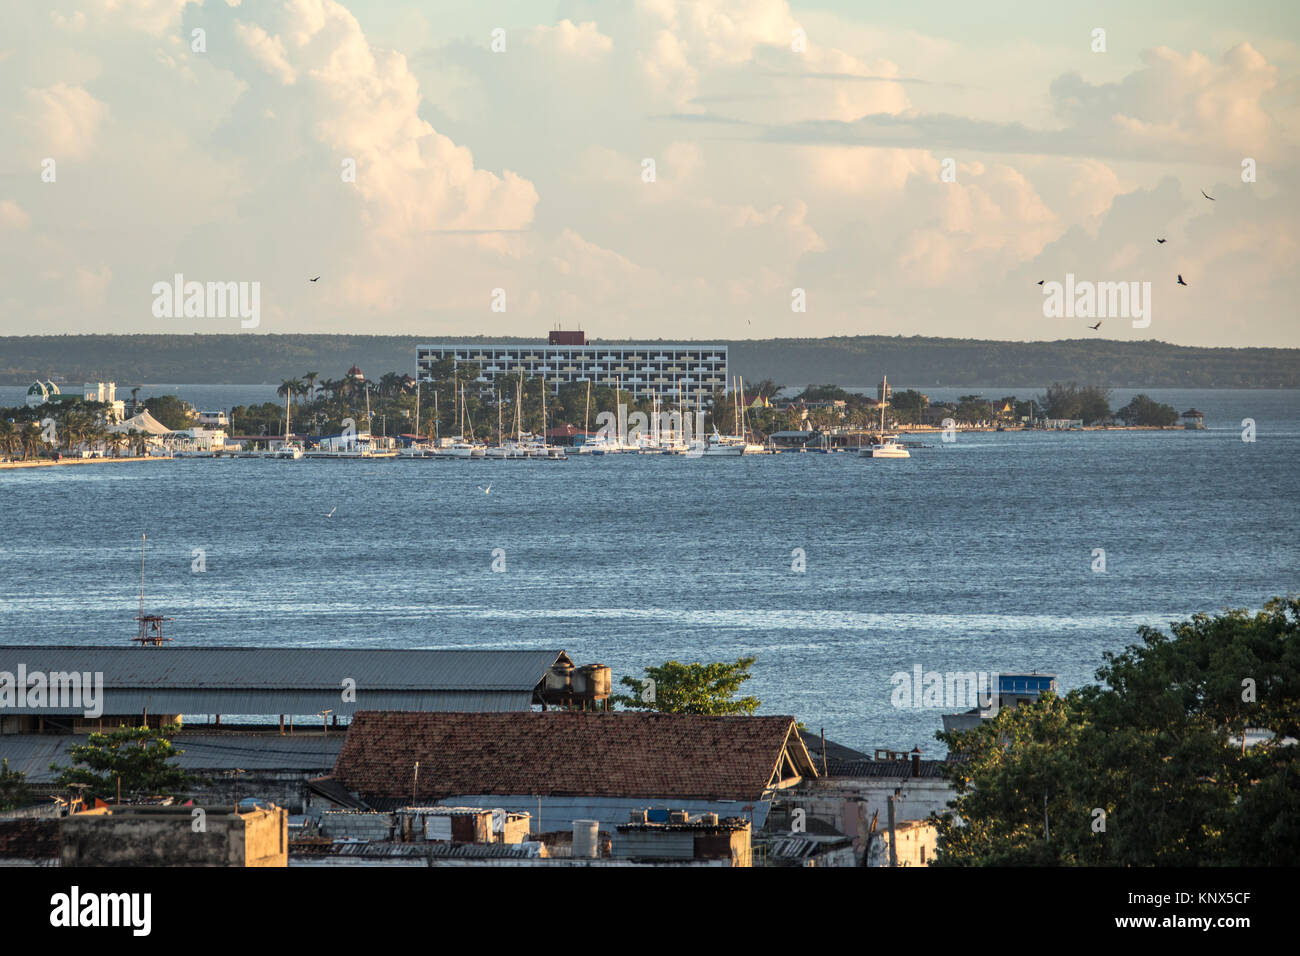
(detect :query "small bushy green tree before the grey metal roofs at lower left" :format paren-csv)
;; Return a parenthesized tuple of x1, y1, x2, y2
(49, 727, 190, 800)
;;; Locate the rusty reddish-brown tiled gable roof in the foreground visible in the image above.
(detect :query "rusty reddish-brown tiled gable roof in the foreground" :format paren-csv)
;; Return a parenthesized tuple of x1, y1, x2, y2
(333, 711, 815, 801)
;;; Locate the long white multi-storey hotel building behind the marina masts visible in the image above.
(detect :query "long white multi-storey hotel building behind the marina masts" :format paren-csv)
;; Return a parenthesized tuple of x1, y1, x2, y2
(416, 332, 728, 402)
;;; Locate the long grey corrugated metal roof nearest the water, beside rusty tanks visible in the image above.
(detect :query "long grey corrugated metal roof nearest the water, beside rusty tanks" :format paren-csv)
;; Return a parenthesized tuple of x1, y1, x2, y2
(0, 645, 568, 714)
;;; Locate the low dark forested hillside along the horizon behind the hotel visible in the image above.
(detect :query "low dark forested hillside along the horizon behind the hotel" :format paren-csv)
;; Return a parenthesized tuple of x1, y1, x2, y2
(0, 334, 1300, 388)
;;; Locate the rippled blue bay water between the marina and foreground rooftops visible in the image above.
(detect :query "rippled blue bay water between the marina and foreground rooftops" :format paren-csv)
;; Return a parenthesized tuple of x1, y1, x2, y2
(0, 392, 1300, 753)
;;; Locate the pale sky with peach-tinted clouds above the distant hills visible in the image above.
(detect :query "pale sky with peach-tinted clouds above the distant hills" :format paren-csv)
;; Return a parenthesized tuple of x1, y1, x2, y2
(0, 0, 1300, 348)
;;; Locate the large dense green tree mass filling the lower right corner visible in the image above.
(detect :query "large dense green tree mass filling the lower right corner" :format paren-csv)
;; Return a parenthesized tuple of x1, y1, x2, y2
(936, 597, 1300, 866)
